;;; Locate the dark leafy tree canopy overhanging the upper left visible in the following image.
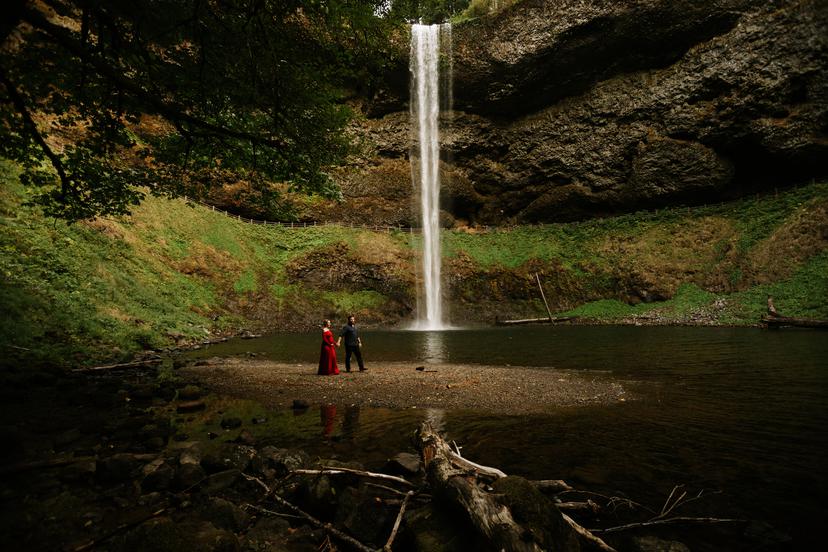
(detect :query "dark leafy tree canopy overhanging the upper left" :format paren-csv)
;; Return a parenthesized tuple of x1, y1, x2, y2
(0, 0, 402, 220)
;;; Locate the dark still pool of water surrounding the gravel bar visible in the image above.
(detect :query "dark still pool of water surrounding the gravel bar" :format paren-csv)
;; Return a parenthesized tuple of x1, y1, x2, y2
(188, 326, 828, 550)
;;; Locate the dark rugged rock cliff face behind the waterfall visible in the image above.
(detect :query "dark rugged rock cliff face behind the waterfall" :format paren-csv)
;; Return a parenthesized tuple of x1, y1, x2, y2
(352, 0, 828, 224)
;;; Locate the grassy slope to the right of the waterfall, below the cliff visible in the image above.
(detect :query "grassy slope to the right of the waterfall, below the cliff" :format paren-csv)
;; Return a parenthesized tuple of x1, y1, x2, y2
(444, 183, 828, 324)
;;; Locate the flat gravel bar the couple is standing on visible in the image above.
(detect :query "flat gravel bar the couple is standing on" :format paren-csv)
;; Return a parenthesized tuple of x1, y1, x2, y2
(181, 358, 631, 414)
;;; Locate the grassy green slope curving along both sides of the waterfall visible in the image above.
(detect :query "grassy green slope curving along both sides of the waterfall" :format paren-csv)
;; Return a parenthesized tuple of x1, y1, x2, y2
(0, 156, 828, 364)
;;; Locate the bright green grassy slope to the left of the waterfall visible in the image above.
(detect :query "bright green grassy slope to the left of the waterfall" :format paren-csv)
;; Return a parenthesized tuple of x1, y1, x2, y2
(0, 163, 410, 363)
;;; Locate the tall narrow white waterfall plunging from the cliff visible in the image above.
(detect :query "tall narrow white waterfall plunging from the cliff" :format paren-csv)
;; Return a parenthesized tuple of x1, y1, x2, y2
(410, 24, 451, 330)
